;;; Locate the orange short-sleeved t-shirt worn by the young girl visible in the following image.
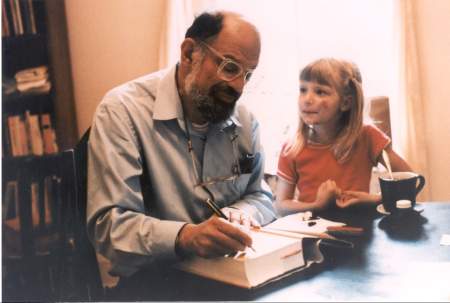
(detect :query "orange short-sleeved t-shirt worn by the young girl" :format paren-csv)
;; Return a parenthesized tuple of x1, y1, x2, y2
(277, 125, 390, 202)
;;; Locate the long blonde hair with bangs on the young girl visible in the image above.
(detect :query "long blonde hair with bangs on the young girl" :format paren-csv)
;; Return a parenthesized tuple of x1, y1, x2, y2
(286, 58, 364, 163)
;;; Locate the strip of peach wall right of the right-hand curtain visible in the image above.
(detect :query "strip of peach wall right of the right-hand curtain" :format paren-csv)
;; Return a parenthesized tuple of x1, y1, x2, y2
(415, 0, 450, 201)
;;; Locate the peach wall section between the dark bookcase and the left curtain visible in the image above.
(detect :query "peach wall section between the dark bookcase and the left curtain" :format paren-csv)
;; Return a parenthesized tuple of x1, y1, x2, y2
(66, 0, 165, 135)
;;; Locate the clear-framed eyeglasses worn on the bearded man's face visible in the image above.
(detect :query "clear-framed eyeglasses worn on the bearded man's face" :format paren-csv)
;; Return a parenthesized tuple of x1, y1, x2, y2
(200, 41, 255, 83)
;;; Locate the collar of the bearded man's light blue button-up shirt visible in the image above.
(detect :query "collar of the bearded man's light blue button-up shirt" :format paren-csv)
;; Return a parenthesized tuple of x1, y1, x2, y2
(153, 65, 242, 129)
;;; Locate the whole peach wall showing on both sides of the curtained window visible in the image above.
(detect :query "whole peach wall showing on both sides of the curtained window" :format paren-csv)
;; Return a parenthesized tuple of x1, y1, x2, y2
(66, 0, 450, 201)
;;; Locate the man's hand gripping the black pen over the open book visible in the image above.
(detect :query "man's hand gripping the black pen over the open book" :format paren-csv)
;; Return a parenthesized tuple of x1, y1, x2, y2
(178, 216, 252, 258)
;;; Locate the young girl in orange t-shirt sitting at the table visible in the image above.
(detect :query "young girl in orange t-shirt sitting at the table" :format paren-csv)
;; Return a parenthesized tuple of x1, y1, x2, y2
(275, 58, 411, 215)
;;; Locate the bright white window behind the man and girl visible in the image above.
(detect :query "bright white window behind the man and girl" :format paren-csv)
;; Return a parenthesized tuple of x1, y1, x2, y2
(192, 0, 397, 173)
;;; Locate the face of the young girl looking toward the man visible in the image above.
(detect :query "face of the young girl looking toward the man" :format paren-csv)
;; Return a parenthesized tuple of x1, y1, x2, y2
(299, 81, 343, 127)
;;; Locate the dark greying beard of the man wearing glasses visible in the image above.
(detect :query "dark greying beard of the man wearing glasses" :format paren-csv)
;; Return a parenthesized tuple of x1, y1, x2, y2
(186, 70, 241, 124)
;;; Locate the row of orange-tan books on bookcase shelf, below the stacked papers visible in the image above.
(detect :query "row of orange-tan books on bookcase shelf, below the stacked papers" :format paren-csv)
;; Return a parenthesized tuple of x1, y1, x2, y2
(4, 111, 58, 157)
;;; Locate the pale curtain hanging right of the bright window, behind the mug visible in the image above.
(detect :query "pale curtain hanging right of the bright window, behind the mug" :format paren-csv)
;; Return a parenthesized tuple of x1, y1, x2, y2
(391, 0, 432, 201)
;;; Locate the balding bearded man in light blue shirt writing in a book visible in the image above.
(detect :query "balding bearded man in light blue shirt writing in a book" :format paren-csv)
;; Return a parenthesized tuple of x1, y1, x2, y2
(87, 12, 275, 288)
